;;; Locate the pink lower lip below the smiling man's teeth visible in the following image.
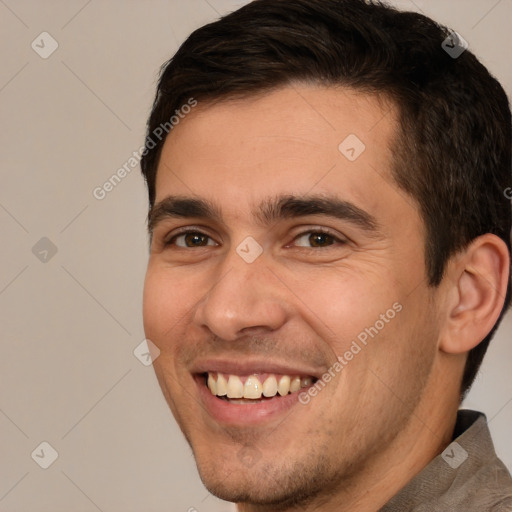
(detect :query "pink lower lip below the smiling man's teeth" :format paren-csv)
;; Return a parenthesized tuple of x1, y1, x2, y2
(195, 376, 307, 426)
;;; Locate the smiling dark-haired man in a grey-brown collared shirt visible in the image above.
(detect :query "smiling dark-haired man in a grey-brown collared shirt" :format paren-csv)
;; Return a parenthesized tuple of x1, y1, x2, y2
(142, 0, 512, 512)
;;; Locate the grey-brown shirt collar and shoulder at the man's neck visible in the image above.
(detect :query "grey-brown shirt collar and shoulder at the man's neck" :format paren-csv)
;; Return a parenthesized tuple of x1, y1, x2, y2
(379, 410, 512, 512)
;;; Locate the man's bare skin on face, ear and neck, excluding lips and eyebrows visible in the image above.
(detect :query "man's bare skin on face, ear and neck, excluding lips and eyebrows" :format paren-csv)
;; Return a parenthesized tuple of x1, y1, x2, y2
(144, 85, 508, 511)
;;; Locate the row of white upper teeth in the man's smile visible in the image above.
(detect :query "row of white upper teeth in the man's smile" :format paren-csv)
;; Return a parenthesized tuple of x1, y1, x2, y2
(208, 373, 313, 400)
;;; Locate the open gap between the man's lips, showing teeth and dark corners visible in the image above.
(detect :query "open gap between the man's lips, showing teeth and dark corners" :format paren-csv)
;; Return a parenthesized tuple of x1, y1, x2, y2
(203, 372, 317, 404)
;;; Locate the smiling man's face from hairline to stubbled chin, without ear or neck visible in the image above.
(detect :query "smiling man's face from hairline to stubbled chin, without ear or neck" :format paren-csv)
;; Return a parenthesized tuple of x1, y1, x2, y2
(144, 86, 436, 506)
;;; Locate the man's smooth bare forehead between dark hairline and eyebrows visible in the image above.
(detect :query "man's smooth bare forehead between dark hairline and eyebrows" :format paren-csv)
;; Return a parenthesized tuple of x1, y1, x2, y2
(156, 85, 406, 224)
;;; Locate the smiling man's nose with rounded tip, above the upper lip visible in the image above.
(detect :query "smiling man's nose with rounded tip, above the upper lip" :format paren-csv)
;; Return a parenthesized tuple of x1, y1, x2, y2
(194, 249, 288, 341)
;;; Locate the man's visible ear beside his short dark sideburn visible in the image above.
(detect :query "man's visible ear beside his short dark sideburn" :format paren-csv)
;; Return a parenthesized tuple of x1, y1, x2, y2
(439, 233, 510, 354)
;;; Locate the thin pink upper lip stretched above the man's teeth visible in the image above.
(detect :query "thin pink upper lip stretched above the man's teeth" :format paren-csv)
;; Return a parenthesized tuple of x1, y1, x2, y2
(191, 356, 324, 378)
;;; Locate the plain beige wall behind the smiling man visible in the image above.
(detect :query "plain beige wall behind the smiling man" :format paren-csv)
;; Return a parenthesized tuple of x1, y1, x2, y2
(0, 0, 512, 512)
